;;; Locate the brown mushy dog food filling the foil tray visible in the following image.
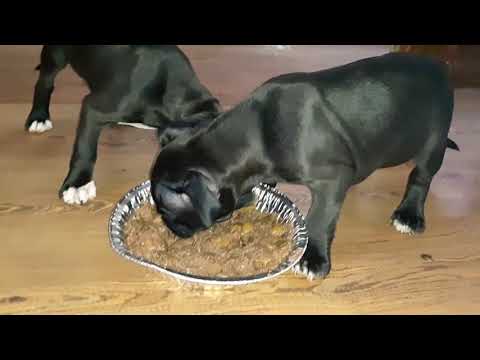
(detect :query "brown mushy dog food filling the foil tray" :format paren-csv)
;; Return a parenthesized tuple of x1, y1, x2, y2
(125, 205, 292, 278)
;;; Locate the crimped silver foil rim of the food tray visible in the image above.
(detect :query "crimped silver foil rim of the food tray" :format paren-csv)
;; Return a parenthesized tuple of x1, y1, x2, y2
(108, 181, 308, 286)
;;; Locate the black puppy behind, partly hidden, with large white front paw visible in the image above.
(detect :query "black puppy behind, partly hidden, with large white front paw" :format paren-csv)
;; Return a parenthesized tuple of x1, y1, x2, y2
(25, 45, 221, 204)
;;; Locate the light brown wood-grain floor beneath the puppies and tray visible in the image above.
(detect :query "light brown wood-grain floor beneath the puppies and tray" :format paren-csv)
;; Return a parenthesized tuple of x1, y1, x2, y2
(0, 45, 480, 314)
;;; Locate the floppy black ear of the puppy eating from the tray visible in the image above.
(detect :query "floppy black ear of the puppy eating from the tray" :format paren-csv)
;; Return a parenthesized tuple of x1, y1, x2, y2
(184, 172, 222, 228)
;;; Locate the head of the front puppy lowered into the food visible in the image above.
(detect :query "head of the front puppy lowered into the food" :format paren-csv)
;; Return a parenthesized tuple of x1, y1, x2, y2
(151, 148, 235, 238)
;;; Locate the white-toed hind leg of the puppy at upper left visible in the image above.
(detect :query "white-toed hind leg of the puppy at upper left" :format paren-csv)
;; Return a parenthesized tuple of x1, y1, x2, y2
(25, 45, 67, 133)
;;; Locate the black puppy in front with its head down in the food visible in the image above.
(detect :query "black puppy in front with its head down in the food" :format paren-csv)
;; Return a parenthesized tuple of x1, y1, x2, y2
(151, 54, 458, 279)
